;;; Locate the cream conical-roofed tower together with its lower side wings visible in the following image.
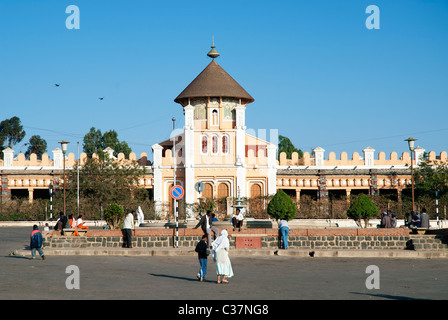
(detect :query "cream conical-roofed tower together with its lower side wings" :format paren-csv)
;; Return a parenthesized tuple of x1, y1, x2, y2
(153, 43, 275, 217)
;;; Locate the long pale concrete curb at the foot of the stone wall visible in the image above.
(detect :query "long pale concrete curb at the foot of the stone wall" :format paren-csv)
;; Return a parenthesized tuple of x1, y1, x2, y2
(11, 248, 448, 259)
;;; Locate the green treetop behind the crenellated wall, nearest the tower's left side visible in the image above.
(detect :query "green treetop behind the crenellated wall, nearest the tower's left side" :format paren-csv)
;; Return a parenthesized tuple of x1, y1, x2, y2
(83, 127, 132, 158)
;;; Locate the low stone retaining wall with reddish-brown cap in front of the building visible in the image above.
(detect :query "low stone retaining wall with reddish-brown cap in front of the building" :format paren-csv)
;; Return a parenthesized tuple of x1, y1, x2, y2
(44, 228, 448, 250)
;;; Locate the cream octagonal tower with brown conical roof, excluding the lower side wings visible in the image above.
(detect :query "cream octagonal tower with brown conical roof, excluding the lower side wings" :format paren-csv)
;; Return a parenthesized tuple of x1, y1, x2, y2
(174, 43, 254, 215)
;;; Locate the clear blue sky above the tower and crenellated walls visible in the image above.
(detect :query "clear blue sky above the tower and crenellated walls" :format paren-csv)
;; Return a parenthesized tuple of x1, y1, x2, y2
(0, 0, 448, 158)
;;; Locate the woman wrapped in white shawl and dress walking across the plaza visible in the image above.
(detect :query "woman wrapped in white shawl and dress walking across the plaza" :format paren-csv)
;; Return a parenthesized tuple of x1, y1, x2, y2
(212, 230, 233, 283)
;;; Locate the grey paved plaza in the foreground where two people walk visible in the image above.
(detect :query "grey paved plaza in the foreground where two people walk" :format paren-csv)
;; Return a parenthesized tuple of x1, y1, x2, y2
(0, 227, 448, 300)
